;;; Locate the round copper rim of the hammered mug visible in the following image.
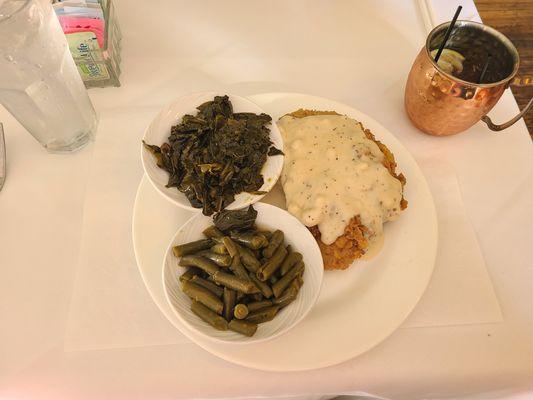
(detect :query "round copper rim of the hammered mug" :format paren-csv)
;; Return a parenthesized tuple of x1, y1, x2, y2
(424, 20, 520, 88)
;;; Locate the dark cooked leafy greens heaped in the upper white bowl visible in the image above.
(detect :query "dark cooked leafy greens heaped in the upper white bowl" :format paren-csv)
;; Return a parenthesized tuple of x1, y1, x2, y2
(143, 96, 283, 215)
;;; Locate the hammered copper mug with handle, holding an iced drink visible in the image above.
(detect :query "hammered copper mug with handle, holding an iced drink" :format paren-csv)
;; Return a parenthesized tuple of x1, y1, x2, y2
(405, 21, 533, 136)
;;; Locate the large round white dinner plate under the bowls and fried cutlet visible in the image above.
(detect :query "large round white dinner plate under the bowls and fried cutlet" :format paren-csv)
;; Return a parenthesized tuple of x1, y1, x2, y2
(133, 93, 437, 371)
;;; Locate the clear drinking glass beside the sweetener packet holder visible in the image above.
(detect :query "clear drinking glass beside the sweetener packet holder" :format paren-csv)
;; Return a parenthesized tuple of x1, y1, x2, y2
(0, 0, 98, 153)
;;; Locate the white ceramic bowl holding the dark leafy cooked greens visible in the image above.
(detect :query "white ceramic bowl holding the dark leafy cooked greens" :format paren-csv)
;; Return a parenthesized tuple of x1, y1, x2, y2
(141, 92, 283, 211)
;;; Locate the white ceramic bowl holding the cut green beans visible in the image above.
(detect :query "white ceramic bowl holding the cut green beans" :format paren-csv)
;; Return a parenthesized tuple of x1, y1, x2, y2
(163, 203, 324, 343)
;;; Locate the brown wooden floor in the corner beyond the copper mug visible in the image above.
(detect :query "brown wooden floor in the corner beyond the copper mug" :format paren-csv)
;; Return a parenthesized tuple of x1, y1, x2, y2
(474, 0, 533, 139)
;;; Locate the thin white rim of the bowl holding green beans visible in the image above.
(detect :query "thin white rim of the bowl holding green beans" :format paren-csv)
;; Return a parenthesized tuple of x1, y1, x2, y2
(161, 203, 324, 346)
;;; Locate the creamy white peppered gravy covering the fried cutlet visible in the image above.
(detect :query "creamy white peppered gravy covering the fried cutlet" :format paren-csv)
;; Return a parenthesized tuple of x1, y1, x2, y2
(278, 115, 402, 244)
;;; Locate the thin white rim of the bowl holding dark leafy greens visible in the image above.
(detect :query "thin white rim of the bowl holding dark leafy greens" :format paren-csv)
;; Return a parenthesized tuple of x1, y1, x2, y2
(140, 91, 285, 213)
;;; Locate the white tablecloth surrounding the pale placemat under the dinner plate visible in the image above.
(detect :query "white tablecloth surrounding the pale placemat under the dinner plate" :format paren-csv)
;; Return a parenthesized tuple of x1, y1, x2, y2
(0, 0, 533, 399)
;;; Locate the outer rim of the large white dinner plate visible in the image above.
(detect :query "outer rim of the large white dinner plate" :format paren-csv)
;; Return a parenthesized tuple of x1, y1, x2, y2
(132, 92, 438, 372)
